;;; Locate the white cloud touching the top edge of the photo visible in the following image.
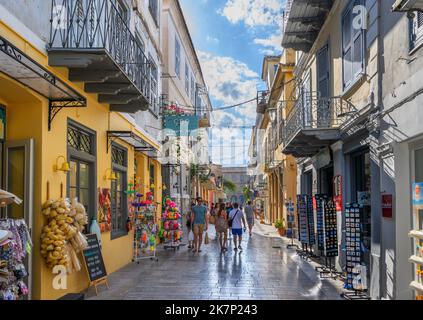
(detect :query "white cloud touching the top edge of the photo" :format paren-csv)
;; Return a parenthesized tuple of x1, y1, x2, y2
(218, 0, 284, 27)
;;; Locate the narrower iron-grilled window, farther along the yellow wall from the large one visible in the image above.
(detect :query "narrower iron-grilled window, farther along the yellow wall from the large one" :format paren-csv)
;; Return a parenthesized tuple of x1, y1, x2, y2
(110, 144, 128, 240)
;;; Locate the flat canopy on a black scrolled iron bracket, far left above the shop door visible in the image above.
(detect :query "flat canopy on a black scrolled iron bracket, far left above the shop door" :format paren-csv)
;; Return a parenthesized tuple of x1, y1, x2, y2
(0, 37, 87, 130)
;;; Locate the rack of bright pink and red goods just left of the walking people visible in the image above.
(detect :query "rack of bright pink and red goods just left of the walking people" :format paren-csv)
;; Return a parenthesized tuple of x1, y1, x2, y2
(159, 198, 183, 251)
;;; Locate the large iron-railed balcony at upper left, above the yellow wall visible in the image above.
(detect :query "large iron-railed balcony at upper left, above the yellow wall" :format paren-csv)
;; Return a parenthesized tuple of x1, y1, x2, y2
(48, 0, 154, 113)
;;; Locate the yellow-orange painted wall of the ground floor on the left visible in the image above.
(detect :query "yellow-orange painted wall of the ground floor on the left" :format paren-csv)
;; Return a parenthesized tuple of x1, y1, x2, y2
(0, 22, 161, 299)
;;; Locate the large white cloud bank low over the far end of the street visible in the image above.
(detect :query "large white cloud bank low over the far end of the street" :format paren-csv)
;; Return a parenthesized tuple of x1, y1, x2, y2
(198, 51, 261, 165)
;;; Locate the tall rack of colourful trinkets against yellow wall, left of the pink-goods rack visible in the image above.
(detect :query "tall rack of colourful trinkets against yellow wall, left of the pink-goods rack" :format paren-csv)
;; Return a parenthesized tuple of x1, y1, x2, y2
(127, 181, 158, 264)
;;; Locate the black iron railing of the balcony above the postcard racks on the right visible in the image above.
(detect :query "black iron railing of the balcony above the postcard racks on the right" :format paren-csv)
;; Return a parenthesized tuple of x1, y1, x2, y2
(282, 94, 357, 156)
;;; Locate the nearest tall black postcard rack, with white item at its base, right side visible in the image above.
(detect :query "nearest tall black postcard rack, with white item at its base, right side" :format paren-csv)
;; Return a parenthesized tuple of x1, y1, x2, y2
(341, 203, 369, 300)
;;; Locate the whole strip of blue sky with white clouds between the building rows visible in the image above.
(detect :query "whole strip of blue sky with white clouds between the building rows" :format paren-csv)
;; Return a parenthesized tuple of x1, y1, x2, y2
(180, 0, 284, 166)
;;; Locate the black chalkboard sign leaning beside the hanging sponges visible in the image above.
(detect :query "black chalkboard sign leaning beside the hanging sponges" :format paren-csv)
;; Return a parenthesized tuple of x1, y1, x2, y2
(84, 234, 107, 282)
